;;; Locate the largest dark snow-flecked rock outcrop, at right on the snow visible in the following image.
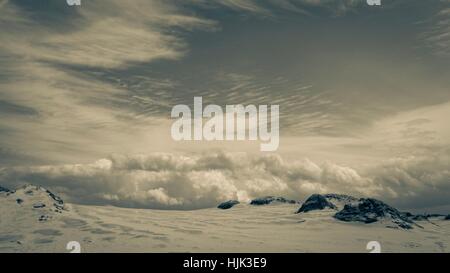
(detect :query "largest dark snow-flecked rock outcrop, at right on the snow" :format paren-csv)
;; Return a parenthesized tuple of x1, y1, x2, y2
(334, 198, 414, 229)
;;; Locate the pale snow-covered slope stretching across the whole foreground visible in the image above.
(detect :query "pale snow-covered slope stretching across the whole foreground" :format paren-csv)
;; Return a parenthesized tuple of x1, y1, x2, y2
(0, 186, 450, 252)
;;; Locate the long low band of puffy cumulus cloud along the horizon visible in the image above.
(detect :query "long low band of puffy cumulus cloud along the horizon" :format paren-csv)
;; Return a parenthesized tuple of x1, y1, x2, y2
(0, 150, 450, 209)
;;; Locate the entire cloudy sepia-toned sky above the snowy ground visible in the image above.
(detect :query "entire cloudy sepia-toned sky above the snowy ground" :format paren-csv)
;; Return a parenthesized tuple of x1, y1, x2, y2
(0, 0, 450, 211)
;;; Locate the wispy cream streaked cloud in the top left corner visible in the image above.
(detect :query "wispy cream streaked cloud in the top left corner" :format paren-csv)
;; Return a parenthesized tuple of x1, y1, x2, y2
(0, 0, 215, 68)
